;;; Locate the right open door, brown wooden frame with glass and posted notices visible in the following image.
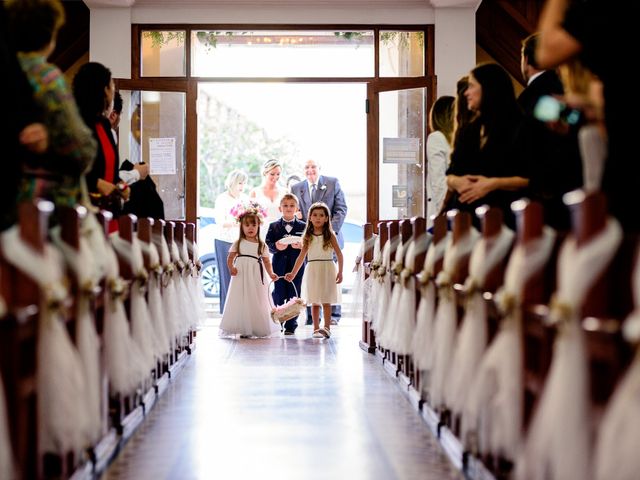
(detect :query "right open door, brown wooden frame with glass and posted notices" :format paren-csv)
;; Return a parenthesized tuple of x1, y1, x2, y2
(367, 77, 435, 223)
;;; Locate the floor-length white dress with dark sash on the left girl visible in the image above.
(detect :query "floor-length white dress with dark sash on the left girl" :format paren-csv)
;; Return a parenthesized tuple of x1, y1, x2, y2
(220, 239, 280, 337)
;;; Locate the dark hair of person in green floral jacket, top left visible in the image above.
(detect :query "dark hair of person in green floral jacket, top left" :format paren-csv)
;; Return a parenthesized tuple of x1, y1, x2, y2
(5, 0, 64, 52)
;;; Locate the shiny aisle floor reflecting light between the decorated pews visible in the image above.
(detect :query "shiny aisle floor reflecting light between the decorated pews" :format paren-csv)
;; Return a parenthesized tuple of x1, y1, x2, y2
(102, 319, 461, 480)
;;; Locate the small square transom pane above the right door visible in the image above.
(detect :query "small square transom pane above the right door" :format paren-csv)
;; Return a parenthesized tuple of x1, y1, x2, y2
(380, 31, 425, 77)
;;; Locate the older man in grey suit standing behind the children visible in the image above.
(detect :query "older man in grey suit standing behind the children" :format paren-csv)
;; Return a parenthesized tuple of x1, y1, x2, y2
(291, 160, 347, 325)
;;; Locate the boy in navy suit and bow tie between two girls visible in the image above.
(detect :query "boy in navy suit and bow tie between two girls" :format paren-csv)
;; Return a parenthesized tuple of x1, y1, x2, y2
(265, 193, 306, 335)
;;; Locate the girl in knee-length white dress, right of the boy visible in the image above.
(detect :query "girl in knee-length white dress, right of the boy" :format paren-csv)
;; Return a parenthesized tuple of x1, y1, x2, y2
(284, 202, 343, 338)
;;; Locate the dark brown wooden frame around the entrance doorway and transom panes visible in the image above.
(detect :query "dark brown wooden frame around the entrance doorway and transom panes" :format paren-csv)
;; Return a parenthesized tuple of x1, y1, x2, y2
(125, 24, 436, 228)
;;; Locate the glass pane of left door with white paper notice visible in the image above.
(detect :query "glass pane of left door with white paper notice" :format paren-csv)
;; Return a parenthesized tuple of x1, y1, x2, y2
(118, 90, 186, 220)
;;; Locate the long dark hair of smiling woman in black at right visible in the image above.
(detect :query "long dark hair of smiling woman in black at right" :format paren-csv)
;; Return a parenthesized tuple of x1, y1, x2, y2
(471, 63, 522, 141)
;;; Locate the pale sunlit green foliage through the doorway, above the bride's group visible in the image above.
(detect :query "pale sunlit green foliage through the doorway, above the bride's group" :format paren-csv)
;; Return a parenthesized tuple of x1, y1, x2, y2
(198, 92, 303, 207)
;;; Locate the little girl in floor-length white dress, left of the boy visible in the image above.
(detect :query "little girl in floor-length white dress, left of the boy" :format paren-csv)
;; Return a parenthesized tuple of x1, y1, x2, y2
(220, 204, 280, 338)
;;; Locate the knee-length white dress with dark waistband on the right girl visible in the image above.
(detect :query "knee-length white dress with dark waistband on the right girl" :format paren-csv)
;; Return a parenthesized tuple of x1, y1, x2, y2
(302, 235, 339, 305)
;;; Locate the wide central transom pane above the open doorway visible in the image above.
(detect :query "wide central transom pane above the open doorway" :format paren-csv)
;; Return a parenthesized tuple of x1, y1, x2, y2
(191, 30, 374, 77)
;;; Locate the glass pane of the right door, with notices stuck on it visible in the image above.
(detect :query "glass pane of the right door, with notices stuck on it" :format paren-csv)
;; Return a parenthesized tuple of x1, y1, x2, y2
(378, 88, 427, 219)
